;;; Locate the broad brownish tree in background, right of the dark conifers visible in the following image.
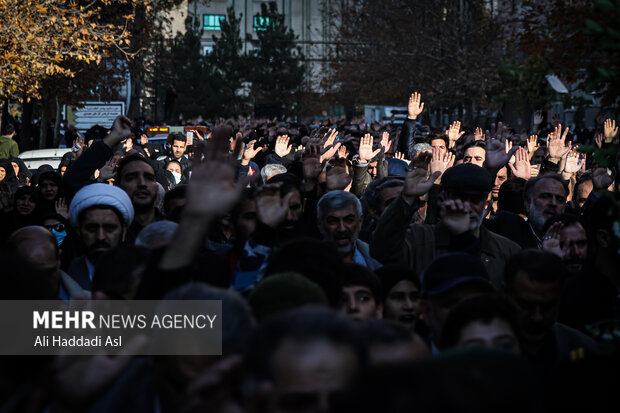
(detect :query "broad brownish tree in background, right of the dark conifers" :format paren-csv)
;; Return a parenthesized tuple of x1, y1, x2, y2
(331, 0, 501, 111)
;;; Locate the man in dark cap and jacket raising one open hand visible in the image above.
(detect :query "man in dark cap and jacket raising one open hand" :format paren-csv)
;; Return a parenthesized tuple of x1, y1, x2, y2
(370, 158, 520, 289)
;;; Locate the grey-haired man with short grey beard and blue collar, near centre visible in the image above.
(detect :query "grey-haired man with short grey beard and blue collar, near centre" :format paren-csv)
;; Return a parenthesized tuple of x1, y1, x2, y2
(317, 191, 381, 270)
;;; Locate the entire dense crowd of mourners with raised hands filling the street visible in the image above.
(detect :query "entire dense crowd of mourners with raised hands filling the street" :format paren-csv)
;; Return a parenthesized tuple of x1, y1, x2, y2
(0, 93, 620, 413)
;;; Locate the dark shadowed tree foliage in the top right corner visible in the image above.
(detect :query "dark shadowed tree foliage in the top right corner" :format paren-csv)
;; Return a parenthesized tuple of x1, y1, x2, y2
(510, 0, 620, 105)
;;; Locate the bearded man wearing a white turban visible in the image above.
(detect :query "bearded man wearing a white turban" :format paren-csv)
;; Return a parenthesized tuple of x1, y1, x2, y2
(67, 184, 134, 291)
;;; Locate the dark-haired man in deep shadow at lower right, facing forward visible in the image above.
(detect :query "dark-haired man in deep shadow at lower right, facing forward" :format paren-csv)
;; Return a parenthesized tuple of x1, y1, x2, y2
(505, 249, 596, 367)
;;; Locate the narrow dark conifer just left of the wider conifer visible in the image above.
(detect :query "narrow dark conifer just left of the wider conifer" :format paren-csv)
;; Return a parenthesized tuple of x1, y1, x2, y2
(207, 7, 248, 116)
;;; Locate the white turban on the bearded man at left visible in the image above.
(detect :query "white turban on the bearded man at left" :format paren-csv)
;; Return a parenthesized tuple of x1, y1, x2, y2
(69, 184, 133, 227)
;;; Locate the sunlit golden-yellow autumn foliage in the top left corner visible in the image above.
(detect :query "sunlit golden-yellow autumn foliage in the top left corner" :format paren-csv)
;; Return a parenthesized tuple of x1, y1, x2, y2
(0, 0, 145, 98)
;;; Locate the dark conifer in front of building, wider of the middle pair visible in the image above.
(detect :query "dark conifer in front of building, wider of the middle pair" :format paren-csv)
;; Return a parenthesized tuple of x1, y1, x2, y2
(248, 2, 305, 108)
